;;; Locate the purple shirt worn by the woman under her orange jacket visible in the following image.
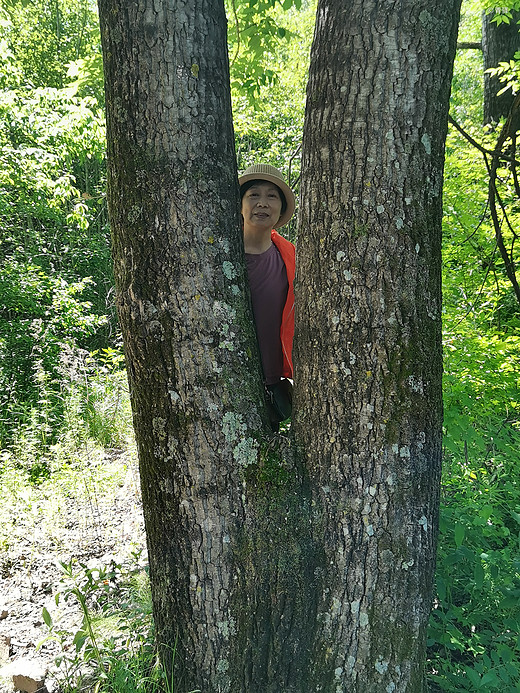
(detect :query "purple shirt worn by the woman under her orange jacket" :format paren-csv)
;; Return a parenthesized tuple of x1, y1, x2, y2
(246, 245, 289, 385)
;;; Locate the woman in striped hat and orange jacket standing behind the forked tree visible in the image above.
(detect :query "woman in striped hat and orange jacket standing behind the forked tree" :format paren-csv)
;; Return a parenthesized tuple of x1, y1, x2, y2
(238, 164, 295, 430)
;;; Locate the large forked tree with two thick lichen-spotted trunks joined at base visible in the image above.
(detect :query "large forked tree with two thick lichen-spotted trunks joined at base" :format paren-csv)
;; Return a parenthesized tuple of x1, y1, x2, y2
(99, 0, 458, 693)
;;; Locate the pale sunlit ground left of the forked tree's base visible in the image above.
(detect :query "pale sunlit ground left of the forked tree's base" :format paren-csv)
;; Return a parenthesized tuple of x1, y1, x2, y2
(0, 451, 146, 693)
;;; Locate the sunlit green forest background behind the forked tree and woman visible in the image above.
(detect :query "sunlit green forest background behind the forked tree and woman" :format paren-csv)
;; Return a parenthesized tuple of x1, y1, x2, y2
(0, 0, 520, 692)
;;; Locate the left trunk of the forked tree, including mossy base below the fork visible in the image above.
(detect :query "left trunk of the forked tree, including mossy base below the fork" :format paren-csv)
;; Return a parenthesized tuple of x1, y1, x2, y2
(99, 0, 315, 693)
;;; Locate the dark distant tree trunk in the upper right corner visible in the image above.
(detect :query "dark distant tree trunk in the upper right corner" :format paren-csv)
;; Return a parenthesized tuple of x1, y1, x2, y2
(482, 11, 520, 131)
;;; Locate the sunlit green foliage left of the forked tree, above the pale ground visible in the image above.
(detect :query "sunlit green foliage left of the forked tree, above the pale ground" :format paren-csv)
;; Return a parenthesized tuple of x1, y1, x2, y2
(0, 0, 110, 450)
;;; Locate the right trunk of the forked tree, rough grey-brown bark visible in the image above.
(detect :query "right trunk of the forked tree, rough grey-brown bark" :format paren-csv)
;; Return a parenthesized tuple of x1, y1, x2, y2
(293, 0, 459, 693)
